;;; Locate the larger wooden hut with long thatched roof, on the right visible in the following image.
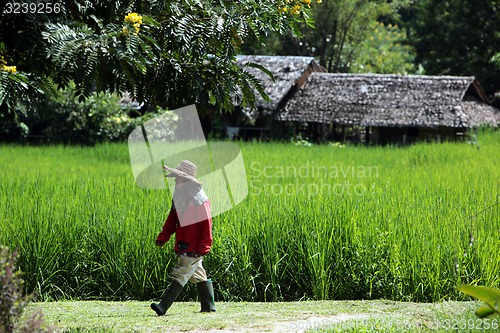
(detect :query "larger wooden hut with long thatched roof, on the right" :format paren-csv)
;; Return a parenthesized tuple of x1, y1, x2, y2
(277, 73, 500, 144)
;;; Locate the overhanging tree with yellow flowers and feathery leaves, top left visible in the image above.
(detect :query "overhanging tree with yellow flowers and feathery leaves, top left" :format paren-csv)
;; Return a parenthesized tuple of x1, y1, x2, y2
(0, 0, 320, 114)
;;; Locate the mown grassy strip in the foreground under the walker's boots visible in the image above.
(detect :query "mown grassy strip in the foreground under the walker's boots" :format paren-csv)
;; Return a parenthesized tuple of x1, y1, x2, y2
(23, 300, 500, 333)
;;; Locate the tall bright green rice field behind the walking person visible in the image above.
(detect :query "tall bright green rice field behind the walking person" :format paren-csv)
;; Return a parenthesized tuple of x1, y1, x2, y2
(0, 131, 500, 302)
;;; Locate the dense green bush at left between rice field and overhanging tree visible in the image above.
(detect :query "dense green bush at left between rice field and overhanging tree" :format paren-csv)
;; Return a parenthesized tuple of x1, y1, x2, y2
(0, 86, 177, 145)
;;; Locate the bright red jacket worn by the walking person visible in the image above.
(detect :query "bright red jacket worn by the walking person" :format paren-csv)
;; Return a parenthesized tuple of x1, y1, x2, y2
(156, 200, 212, 255)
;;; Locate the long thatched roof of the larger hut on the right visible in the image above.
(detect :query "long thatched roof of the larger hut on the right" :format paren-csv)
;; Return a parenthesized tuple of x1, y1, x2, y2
(277, 73, 499, 128)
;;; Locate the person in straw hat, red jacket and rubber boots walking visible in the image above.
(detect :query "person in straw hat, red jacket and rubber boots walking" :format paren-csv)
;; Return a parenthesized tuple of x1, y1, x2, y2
(151, 160, 215, 316)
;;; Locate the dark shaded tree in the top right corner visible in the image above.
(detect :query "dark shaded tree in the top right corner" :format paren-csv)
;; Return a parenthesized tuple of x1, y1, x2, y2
(405, 0, 500, 94)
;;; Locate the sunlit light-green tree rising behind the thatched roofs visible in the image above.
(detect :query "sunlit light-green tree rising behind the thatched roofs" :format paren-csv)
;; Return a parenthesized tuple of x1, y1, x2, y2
(248, 0, 413, 73)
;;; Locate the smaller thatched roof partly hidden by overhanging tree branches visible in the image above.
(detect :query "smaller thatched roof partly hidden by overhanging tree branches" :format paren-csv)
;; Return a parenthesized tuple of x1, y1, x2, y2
(236, 55, 319, 115)
